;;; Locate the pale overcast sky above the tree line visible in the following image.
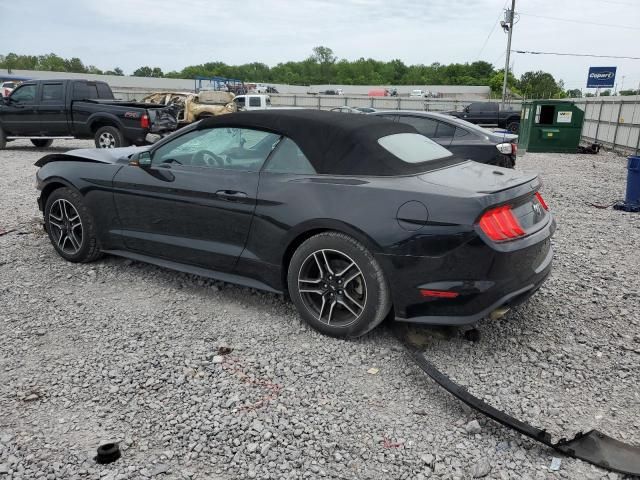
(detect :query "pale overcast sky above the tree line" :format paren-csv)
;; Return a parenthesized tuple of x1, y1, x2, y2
(0, 0, 640, 88)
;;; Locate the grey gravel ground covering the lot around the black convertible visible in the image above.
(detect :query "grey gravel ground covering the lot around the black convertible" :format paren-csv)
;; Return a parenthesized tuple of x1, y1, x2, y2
(0, 141, 640, 480)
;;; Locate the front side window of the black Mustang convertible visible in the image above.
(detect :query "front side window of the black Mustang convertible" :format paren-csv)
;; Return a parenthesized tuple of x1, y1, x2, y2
(151, 127, 280, 172)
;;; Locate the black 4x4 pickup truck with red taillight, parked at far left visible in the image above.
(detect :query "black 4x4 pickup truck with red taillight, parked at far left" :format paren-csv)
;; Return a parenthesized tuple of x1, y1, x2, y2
(0, 80, 178, 150)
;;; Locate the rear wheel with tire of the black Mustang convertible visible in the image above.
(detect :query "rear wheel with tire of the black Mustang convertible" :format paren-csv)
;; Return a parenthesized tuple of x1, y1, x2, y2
(287, 232, 391, 338)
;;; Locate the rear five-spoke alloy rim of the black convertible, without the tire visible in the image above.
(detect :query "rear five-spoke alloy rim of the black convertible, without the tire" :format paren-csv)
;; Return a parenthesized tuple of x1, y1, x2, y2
(298, 249, 367, 327)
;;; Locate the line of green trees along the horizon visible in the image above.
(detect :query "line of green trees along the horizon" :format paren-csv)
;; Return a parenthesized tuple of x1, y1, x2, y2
(0, 46, 624, 98)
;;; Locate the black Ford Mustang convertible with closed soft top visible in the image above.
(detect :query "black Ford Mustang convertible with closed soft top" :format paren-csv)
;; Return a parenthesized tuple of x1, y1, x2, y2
(36, 110, 555, 337)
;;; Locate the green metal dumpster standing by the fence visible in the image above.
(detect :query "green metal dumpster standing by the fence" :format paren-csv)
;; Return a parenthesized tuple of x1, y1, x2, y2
(518, 100, 584, 154)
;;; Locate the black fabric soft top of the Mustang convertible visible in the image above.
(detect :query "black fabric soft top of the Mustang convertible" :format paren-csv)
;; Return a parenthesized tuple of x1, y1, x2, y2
(197, 109, 453, 176)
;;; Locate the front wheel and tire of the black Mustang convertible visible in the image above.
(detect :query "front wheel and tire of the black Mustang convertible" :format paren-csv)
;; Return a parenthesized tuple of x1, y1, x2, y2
(44, 188, 102, 263)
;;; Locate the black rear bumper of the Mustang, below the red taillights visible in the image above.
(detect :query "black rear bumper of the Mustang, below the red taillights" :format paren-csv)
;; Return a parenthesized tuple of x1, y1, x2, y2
(377, 221, 555, 325)
